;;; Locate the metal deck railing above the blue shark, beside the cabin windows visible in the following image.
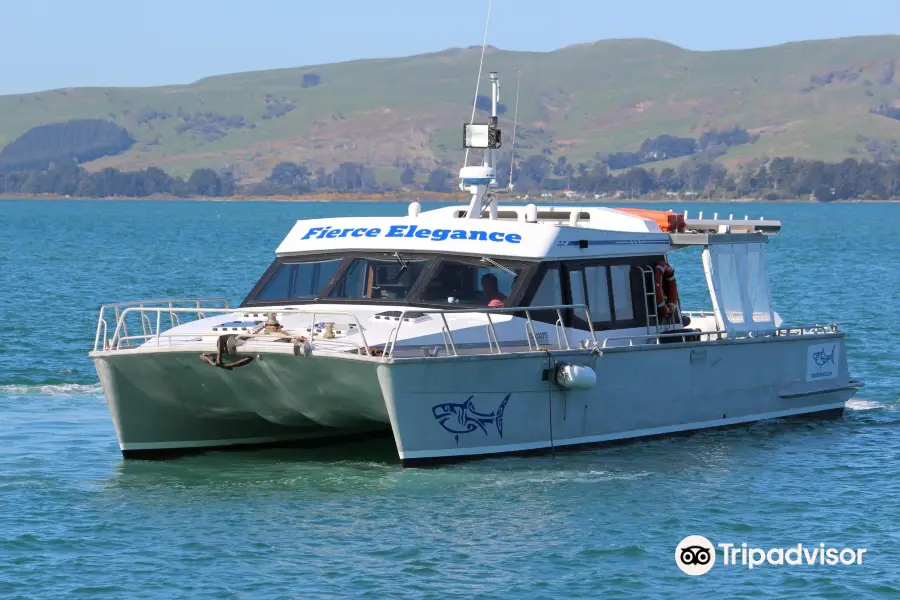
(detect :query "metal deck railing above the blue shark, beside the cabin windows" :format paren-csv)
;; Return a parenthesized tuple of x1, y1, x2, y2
(384, 304, 598, 358)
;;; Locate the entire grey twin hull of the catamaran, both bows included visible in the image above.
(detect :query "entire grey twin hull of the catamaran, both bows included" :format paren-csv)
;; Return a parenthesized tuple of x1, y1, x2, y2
(94, 334, 856, 466)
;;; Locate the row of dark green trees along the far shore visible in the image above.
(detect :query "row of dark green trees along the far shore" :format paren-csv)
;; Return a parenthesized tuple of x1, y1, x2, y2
(0, 154, 900, 202)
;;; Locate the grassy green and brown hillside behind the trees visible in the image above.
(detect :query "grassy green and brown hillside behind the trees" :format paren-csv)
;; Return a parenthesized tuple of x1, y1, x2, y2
(0, 36, 900, 180)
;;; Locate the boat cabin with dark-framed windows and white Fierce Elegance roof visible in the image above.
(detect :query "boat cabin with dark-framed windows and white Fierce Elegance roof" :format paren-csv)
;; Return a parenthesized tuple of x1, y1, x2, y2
(242, 205, 771, 332)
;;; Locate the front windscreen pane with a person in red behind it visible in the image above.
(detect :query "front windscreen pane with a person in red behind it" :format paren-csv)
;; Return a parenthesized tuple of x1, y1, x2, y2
(419, 261, 521, 308)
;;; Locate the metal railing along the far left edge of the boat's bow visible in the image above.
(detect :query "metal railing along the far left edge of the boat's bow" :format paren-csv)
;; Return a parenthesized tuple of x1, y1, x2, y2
(94, 298, 232, 351)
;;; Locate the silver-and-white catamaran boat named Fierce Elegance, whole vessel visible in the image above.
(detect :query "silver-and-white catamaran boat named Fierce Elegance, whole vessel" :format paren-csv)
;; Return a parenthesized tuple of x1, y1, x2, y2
(90, 73, 862, 466)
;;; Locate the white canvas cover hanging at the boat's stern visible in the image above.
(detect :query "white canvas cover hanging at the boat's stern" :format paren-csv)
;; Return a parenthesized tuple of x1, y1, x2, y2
(703, 243, 776, 334)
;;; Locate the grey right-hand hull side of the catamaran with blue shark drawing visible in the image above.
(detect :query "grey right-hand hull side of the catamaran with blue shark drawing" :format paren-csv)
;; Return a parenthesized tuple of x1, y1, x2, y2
(382, 334, 857, 466)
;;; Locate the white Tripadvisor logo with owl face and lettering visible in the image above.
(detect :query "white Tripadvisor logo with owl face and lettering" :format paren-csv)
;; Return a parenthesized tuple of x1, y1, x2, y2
(675, 535, 867, 575)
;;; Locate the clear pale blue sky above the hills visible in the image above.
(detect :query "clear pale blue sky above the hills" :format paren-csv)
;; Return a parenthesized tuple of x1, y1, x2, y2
(0, 0, 900, 94)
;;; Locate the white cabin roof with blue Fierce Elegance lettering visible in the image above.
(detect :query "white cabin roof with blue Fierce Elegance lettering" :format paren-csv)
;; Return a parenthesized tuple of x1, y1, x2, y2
(276, 205, 672, 260)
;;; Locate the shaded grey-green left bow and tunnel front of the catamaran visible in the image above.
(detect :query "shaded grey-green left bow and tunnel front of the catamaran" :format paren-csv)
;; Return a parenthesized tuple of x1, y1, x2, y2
(93, 350, 390, 458)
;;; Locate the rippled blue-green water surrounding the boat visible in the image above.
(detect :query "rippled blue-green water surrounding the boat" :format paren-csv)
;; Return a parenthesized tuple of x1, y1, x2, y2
(0, 201, 900, 598)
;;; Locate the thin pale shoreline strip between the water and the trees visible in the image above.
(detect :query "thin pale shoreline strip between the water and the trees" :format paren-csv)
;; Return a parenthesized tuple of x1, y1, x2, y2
(0, 192, 900, 205)
